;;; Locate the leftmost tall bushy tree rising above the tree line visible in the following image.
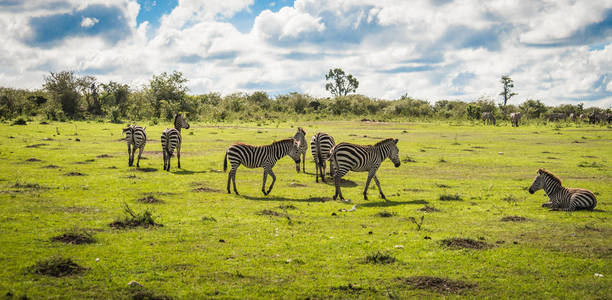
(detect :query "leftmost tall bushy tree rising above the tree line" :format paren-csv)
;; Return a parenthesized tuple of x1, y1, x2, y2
(43, 71, 82, 119)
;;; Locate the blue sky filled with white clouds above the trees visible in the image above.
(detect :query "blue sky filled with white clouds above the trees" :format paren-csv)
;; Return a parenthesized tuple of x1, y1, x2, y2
(0, 0, 612, 107)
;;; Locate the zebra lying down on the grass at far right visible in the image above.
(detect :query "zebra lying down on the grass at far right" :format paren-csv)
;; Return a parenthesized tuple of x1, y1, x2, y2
(529, 169, 597, 211)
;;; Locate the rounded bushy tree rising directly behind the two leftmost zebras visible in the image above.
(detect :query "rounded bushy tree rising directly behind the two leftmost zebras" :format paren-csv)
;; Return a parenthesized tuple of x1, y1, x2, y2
(148, 71, 189, 119)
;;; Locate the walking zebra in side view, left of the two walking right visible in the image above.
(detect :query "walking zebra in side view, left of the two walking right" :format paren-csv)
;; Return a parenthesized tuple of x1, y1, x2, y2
(223, 138, 300, 196)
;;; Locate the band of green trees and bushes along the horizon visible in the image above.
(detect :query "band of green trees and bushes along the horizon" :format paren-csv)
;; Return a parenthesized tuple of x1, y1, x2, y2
(0, 70, 610, 123)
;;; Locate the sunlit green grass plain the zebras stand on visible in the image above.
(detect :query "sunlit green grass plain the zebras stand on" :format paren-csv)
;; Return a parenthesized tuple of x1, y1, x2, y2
(0, 121, 612, 299)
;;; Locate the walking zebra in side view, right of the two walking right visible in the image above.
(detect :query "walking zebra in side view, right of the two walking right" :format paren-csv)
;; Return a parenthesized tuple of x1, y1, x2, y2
(329, 138, 400, 200)
